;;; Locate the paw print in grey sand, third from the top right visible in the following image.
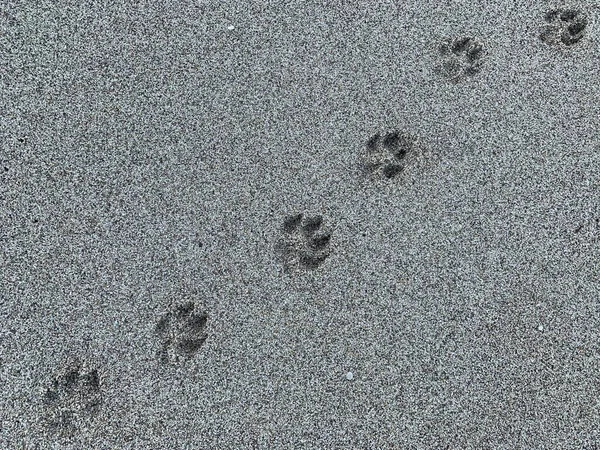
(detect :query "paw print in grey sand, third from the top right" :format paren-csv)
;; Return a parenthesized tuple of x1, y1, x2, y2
(362, 131, 415, 179)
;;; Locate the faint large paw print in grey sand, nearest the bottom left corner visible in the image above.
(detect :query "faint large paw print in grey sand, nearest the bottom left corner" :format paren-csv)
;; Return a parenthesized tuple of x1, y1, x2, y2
(43, 361, 102, 435)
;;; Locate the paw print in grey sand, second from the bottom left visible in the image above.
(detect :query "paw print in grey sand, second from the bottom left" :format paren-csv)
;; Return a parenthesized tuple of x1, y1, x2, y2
(155, 302, 208, 363)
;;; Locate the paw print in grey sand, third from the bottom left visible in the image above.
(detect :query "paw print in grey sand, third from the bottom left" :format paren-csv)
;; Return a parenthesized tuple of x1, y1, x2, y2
(276, 214, 331, 270)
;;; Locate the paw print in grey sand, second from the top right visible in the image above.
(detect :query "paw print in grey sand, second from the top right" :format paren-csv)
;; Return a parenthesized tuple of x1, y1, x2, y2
(437, 37, 483, 82)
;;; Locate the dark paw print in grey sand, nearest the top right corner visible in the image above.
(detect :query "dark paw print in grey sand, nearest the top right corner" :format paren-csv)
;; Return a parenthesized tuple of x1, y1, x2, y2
(540, 8, 588, 47)
